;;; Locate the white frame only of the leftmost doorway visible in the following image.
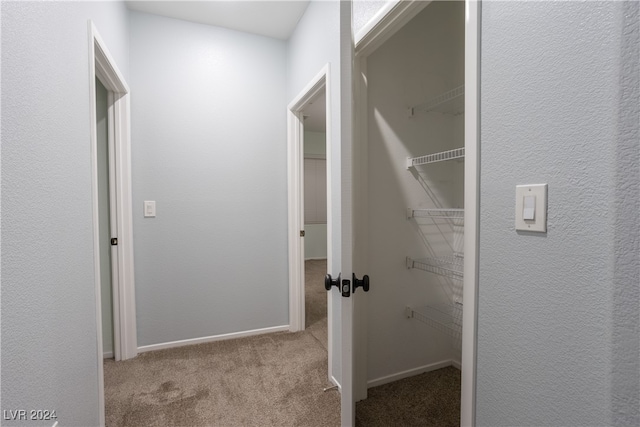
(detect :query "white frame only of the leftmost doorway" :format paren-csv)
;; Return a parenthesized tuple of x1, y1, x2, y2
(88, 20, 138, 425)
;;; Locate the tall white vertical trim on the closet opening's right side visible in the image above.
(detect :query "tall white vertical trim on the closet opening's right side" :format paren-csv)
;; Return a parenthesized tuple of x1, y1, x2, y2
(460, 0, 480, 427)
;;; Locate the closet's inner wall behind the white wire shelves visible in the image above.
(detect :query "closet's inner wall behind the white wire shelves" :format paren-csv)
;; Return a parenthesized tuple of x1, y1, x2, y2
(367, 2, 464, 381)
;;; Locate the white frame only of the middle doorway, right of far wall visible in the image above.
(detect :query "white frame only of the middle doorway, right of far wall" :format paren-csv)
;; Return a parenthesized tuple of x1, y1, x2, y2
(287, 64, 337, 384)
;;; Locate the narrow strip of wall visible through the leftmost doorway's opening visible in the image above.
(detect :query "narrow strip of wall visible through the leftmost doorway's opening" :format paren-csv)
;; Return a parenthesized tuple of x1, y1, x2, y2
(96, 78, 113, 354)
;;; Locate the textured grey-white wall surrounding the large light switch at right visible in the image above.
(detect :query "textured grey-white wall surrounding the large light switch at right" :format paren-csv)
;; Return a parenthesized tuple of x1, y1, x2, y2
(476, 2, 640, 426)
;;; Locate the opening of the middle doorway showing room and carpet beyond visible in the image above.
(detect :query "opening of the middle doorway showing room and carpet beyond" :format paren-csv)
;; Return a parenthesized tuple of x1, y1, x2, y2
(302, 92, 328, 349)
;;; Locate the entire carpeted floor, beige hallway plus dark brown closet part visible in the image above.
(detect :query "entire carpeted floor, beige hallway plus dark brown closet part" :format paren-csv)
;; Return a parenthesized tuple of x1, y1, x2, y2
(104, 261, 460, 427)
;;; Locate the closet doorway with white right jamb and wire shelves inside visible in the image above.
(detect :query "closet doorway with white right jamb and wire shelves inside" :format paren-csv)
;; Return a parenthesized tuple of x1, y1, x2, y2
(355, 1, 478, 425)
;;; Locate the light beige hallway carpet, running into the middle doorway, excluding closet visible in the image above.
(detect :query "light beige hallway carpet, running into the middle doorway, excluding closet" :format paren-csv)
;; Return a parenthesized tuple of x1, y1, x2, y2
(104, 261, 340, 427)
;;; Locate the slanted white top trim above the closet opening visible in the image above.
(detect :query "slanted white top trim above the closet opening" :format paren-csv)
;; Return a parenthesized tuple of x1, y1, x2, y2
(355, 0, 431, 58)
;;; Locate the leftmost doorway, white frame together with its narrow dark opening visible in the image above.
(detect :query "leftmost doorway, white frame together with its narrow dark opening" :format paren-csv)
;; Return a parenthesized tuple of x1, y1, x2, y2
(87, 20, 138, 425)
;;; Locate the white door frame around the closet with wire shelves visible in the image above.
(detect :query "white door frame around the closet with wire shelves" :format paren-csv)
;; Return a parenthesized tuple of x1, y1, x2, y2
(354, 0, 480, 426)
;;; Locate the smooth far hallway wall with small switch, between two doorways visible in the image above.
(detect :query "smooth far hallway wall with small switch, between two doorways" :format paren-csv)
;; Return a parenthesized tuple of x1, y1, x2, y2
(131, 12, 288, 346)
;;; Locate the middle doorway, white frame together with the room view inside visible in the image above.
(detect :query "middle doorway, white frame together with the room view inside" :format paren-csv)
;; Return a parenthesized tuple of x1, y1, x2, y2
(287, 64, 338, 385)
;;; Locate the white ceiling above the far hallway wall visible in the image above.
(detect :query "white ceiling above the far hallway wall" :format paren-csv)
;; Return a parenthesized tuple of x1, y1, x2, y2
(126, 0, 309, 40)
